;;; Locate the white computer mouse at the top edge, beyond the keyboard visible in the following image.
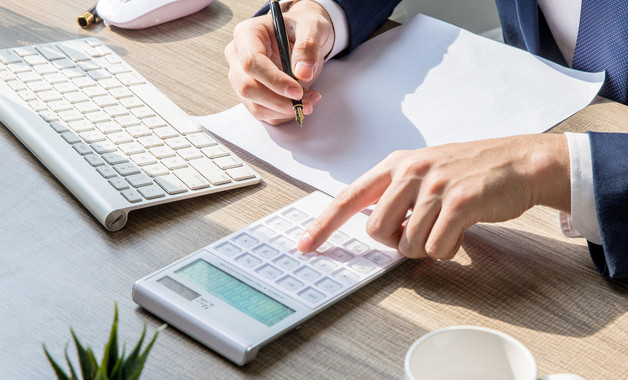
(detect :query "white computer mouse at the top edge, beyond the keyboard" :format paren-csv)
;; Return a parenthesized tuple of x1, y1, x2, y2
(96, 0, 214, 29)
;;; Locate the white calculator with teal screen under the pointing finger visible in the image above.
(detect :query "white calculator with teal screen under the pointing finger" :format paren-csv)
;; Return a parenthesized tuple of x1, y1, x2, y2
(133, 192, 404, 365)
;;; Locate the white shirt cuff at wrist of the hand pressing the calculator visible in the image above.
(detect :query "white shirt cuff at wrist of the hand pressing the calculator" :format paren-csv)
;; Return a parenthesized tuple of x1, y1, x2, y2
(559, 133, 602, 244)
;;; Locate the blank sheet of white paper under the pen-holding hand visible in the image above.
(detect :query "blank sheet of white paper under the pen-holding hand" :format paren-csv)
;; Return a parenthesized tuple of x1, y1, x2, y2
(195, 15, 604, 196)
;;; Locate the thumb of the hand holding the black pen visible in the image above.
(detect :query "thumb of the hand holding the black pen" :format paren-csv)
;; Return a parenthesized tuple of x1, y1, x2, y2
(292, 16, 333, 82)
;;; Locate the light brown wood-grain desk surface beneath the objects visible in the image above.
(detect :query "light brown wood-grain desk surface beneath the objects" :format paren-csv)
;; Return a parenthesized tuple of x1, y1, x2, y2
(0, 0, 628, 379)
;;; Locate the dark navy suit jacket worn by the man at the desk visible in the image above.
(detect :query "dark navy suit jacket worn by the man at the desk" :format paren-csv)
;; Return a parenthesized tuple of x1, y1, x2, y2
(255, 0, 628, 277)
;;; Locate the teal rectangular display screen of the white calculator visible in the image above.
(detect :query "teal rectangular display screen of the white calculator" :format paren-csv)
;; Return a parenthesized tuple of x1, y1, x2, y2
(176, 259, 295, 326)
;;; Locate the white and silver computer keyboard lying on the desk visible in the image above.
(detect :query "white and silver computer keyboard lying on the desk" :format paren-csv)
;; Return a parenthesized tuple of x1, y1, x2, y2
(0, 38, 261, 231)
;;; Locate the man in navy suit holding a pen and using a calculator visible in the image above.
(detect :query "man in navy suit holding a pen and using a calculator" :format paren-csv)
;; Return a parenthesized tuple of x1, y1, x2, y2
(225, 0, 628, 277)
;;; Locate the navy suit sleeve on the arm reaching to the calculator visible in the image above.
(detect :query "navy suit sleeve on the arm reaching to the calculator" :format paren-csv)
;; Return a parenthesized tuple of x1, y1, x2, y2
(588, 132, 628, 278)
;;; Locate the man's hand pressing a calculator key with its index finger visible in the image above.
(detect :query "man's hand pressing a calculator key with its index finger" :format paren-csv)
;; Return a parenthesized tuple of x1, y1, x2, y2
(297, 134, 571, 259)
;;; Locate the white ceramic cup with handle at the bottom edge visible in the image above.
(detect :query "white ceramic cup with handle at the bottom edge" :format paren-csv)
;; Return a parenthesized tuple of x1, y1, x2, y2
(405, 326, 584, 380)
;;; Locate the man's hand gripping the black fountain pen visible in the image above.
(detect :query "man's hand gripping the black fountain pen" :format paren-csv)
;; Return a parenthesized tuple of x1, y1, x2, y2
(225, 0, 334, 125)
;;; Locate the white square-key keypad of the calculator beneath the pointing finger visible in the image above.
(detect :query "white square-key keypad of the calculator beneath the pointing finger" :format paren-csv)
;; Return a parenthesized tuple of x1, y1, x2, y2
(207, 207, 401, 307)
